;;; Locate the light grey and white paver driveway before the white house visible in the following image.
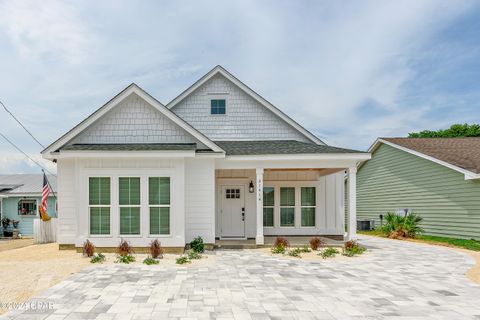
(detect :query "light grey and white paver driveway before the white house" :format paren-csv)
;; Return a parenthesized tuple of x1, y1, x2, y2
(2, 237, 480, 319)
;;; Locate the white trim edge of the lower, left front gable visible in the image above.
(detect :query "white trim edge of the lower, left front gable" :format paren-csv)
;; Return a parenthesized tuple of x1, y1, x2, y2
(42, 83, 224, 157)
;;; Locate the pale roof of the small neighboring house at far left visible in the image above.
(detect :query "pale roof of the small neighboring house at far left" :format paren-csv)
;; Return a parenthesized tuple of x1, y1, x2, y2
(0, 174, 57, 196)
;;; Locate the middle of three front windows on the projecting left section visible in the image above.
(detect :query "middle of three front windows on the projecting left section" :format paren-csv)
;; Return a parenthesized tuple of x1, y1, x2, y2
(118, 177, 140, 235)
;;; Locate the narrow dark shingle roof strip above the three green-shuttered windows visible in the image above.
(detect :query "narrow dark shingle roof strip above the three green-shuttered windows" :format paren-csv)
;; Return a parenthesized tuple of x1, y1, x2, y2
(61, 143, 197, 151)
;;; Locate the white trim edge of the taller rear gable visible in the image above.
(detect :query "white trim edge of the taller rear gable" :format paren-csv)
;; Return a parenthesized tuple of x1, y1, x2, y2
(167, 65, 325, 145)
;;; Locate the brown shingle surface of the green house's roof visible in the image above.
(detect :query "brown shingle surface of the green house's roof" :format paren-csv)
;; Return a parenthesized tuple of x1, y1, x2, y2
(380, 137, 480, 173)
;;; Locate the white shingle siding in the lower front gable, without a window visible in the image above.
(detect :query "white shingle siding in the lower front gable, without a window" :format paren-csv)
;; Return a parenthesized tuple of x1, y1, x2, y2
(72, 93, 203, 147)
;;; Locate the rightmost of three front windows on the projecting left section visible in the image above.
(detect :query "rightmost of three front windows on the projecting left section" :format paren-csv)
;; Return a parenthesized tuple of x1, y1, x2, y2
(148, 177, 170, 235)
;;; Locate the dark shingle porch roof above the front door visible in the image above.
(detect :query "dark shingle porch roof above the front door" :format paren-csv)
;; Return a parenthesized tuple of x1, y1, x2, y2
(214, 140, 362, 155)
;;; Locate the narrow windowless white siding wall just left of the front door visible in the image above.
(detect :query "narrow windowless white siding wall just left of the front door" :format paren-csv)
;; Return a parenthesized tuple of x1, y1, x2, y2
(185, 159, 215, 243)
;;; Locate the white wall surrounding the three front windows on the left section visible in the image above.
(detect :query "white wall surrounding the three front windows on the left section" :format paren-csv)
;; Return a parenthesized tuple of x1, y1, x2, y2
(58, 157, 185, 247)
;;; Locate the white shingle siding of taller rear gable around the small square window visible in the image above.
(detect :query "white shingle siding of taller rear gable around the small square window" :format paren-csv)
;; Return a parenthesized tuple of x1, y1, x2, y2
(172, 75, 311, 142)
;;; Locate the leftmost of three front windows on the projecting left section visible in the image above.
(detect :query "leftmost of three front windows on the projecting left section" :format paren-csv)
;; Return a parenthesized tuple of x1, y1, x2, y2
(88, 177, 110, 235)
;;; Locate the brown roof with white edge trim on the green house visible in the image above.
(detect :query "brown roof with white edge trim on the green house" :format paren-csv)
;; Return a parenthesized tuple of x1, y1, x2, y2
(368, 137, 480, 179)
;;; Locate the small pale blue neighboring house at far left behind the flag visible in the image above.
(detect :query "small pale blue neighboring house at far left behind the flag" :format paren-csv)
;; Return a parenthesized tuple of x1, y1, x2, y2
(0, 174, 57, 237)
